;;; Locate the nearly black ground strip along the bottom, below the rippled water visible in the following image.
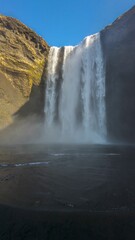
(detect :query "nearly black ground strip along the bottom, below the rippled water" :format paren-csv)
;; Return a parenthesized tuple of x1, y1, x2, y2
(0, 206, 135, 240)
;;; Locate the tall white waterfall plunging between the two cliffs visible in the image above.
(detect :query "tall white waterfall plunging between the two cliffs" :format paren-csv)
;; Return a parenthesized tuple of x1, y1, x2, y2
(45, 33, 106, 143)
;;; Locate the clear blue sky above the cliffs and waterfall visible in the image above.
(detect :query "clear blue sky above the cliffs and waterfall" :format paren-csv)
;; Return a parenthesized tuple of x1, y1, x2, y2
(0, 0, 135, 46)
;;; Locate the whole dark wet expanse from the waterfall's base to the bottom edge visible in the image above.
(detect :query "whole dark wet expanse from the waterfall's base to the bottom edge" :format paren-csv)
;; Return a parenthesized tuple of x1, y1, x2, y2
(0, 145, 135, 240)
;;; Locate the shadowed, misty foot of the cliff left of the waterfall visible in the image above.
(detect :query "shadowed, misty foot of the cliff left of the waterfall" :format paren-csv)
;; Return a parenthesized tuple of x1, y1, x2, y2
(0, 66, 46, 144)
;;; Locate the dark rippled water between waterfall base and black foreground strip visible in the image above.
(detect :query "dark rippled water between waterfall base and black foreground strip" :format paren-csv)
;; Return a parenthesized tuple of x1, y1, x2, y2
(0, 142, 135, 211)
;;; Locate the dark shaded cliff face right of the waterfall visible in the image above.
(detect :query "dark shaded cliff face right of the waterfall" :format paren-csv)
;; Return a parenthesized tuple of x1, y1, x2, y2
(101, 7, 135, 142)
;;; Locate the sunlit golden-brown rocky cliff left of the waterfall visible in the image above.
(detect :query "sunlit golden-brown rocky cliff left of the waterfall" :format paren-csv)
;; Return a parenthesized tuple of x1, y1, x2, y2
(0, 16, 49, 128)
